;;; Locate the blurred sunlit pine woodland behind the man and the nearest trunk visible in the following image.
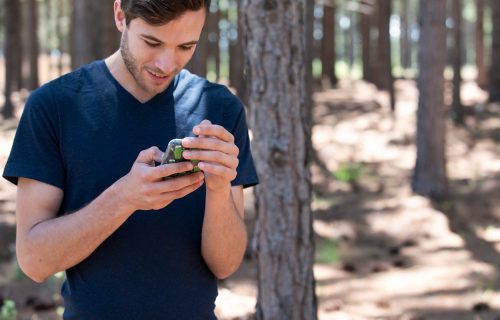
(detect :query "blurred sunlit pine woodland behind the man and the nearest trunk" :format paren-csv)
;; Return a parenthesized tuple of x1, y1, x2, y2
(0, 0, 500, 320)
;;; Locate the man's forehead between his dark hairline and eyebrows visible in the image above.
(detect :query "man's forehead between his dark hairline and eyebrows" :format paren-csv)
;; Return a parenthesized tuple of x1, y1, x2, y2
(128, 8, 206, 43)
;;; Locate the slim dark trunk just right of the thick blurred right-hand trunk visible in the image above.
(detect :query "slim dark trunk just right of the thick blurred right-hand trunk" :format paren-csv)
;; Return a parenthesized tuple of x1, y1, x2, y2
(452, 0, 464, 125)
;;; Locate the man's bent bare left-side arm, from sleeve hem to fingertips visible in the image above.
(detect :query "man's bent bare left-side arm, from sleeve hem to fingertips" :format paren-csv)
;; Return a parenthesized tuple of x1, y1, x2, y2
(16, 148, 203, 282)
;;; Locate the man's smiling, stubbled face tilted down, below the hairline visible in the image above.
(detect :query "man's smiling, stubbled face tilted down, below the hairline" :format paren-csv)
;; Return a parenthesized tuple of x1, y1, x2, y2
(120, 8, 206, 97)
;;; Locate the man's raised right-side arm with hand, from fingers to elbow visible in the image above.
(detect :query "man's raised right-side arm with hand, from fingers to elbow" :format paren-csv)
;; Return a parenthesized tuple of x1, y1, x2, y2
(183, 120, 247, 279)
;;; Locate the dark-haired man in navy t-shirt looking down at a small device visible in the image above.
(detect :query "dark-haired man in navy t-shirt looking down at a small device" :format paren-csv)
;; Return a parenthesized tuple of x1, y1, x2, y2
(0, 0, 258, 319)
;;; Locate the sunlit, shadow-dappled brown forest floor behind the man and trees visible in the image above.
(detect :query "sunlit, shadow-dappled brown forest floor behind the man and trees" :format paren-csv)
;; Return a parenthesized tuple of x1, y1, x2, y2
(0, 80, 500, 320)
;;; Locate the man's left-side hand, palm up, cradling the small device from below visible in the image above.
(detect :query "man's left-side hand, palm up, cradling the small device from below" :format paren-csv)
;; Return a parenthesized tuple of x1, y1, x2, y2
(116, 147, 203, 211)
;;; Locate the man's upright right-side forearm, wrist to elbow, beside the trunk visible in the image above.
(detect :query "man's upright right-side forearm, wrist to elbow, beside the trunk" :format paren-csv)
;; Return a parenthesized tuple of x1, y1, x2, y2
(202, 187, 247, 279)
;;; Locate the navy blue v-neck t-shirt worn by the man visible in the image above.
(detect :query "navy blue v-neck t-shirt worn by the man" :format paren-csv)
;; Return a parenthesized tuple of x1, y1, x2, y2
(3, 61, 258, 319)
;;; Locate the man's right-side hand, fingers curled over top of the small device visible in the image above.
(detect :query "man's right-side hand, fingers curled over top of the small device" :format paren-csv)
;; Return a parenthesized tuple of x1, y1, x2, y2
(182, 120, 239, 190)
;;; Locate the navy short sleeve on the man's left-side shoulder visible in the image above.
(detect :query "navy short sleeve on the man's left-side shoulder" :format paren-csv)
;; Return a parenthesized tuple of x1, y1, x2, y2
(3, 85, 64, 189)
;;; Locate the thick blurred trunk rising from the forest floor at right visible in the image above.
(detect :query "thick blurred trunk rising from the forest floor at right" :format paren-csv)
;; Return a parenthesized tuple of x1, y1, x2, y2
(412, 0, 447, 198)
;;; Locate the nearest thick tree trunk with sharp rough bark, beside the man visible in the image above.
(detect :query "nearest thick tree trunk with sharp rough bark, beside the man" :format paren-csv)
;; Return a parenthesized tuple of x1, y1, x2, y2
(242, 0, 317, 320)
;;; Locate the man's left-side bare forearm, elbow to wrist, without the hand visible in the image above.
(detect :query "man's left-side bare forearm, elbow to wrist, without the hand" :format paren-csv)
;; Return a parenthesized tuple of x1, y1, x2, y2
(17, 182, 132, 282)
